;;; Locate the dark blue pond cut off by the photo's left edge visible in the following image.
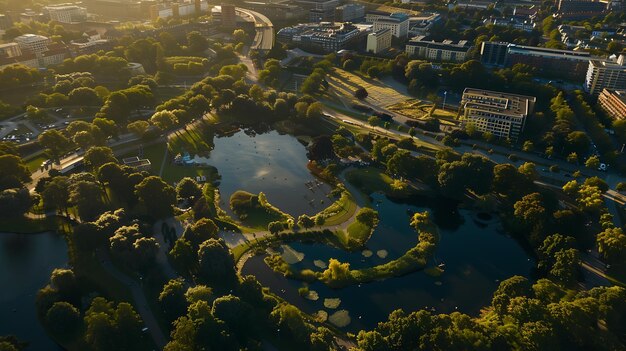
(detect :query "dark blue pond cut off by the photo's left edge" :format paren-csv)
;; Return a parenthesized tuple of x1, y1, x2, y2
(0, 233, 68, 350)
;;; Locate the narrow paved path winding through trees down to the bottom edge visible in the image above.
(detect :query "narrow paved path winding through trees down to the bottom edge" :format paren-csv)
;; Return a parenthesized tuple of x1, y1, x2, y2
(96, 250, 167, 350)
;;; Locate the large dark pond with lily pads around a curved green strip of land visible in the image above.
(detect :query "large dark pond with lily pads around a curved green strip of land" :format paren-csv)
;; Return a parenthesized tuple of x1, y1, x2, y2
(243, 194, 534, 331)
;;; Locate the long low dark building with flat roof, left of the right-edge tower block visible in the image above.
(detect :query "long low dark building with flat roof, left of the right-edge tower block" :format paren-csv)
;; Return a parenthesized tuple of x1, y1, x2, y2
(480, 41, 600, 82)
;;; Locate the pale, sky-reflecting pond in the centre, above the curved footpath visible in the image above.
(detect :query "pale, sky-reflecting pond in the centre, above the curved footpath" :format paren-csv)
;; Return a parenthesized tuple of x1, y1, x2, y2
(208, 131, 332, 216)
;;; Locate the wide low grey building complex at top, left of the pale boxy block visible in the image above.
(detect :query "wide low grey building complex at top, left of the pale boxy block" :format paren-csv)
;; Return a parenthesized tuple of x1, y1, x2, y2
(276, 22, 367, 52)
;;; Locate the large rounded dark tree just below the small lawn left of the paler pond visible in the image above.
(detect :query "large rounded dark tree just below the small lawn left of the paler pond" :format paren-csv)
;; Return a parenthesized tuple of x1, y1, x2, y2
(135, 176, 176, 218)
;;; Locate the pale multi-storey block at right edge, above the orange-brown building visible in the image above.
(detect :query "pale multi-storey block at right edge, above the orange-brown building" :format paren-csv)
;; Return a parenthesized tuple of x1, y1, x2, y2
(585, 55, 626, 96)
